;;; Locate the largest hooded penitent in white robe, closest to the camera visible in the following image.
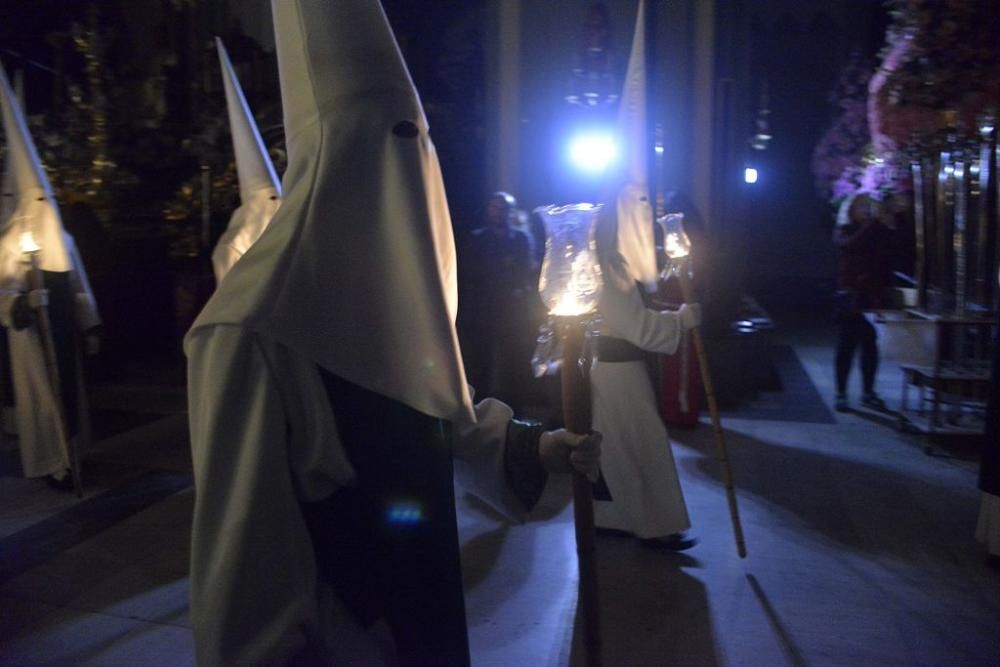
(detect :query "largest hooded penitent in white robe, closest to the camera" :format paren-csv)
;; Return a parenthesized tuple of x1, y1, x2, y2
(185, 0, 537, 664)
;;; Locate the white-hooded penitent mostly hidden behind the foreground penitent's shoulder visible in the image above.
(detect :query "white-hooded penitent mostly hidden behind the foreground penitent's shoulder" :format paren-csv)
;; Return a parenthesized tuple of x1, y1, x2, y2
(212, 37, 281, 284)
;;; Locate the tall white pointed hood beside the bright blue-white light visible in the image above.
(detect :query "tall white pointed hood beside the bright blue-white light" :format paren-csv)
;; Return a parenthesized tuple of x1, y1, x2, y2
(615, 0, 659, 290)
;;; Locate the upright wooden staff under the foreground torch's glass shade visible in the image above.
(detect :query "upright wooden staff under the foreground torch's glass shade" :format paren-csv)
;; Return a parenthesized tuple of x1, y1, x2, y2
(560, 317, 601, 667)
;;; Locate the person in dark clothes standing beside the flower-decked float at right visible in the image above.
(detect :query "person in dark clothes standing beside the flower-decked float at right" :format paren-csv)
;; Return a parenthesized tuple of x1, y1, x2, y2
(833, 193, 893, 412)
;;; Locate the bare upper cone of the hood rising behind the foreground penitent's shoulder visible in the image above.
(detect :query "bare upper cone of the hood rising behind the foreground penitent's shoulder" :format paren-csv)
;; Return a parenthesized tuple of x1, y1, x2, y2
(215, 37, 281, 204)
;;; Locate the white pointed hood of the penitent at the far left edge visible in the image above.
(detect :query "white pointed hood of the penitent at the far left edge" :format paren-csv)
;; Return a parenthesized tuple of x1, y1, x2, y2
(0, 62, 70, 271)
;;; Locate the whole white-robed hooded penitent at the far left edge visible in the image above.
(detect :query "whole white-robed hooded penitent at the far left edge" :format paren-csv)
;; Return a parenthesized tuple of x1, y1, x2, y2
(0, 62, 100, 477)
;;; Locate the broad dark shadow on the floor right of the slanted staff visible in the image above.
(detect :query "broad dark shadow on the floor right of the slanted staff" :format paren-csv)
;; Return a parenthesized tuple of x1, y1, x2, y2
(672, 426, 981, 564)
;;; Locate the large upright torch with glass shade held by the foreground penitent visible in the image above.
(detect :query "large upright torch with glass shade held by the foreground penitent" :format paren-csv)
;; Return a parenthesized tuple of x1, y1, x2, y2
(538, 204, 602, 665)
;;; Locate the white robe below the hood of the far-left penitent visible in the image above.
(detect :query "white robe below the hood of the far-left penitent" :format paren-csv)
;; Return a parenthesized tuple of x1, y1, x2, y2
(0, 233, 101, 477)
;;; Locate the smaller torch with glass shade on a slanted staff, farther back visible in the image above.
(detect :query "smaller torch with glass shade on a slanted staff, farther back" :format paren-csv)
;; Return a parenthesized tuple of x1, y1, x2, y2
(657, 213, 747, 558)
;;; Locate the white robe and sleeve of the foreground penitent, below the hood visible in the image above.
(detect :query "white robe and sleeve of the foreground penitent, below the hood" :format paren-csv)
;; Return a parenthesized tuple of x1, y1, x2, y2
(186, 324, 524, 665)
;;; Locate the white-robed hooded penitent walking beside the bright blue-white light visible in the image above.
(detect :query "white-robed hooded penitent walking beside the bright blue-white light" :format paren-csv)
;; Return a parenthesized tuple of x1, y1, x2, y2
(590, 2, 690, 538)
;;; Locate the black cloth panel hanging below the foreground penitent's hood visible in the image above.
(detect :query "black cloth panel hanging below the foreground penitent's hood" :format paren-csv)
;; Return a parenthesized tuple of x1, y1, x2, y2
(301, 369, 469, 667)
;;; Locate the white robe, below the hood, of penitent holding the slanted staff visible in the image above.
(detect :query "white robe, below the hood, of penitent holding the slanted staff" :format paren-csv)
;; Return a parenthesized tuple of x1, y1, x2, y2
(590, 253, 691, 538)
